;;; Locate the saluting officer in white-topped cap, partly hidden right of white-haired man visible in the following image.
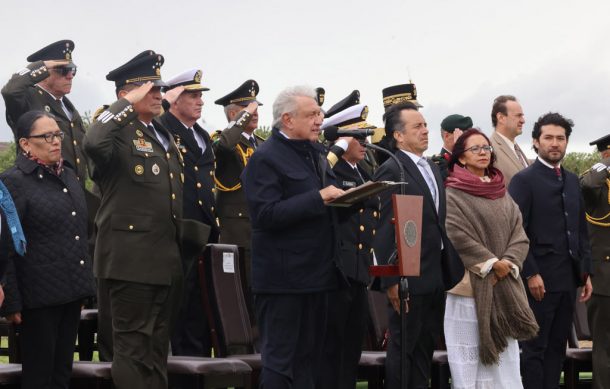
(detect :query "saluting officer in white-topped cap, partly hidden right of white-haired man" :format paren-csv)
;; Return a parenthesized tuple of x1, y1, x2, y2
(316, 101, 380, 389)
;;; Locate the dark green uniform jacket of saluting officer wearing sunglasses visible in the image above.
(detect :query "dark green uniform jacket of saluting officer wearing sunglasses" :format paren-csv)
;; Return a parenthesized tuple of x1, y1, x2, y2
(2, 61, 87, 184)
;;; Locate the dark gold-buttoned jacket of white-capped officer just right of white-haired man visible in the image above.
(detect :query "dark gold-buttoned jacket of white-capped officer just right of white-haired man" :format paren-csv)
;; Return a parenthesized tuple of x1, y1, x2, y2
(333, 159, 380, 284)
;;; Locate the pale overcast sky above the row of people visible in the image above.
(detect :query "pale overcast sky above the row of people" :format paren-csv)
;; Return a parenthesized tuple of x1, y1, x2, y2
(0, 0, 610, 156)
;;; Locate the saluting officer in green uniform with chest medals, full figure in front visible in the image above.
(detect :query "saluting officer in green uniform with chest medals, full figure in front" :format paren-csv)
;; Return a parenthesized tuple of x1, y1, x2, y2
(84, 51, 183, 389)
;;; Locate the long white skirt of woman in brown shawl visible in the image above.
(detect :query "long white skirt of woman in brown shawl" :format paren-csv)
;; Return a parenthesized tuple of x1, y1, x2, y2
(445, 294, 523, 389)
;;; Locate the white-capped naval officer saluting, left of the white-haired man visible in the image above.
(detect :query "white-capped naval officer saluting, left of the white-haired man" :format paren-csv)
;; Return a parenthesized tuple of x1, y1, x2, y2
(159, 69, 218, 356)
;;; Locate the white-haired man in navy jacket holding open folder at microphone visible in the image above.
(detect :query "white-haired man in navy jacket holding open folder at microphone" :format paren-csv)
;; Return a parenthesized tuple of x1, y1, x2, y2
(241, 86, 346, 388)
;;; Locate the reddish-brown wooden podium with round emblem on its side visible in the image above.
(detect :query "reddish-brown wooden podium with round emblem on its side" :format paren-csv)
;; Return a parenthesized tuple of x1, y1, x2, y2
(369, 194, 423, 277)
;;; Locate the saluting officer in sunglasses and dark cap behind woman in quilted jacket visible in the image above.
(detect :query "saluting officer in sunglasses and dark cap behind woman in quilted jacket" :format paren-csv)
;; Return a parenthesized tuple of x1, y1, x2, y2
(2, 40, 87, 188)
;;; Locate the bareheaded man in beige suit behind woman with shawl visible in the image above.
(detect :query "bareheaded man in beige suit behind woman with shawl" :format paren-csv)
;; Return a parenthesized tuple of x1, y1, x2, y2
(490, 95, 530, 188)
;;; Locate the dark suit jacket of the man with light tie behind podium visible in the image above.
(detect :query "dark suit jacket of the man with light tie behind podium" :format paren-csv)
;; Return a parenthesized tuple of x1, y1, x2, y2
(373, 150, 464, 295)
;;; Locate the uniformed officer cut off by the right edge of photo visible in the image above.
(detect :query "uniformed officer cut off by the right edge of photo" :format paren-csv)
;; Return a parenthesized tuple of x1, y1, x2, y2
(580, 135, 610, 389)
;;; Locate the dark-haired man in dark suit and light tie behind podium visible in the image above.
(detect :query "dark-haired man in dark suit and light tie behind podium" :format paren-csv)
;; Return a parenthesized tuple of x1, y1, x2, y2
(373, 103, 464, 389)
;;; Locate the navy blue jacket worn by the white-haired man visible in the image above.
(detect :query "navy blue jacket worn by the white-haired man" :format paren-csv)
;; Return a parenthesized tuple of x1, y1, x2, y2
(241, 128, 338, 293)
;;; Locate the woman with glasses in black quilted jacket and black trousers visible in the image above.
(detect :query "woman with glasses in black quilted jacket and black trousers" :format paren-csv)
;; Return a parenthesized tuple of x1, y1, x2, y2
(0, 111, 94, 389)
